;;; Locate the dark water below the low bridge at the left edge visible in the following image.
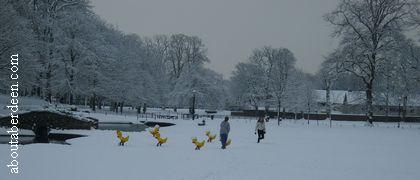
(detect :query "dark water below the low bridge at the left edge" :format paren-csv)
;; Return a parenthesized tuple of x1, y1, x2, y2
(0, 133, 86, 145)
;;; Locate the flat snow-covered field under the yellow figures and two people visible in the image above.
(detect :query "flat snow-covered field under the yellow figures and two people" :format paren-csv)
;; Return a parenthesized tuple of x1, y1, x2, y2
(0, 110, 420, 180)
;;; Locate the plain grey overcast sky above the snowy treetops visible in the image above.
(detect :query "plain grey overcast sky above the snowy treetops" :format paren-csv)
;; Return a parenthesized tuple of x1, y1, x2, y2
(91, 0, 338, 77)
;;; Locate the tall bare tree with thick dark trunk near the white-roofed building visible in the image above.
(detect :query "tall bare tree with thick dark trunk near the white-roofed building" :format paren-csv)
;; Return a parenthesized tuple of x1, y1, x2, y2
(325, 0, 418, 124)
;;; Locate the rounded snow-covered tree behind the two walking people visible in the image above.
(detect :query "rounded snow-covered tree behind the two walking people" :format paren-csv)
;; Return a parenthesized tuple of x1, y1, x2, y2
(230, 46, 313, 117)
